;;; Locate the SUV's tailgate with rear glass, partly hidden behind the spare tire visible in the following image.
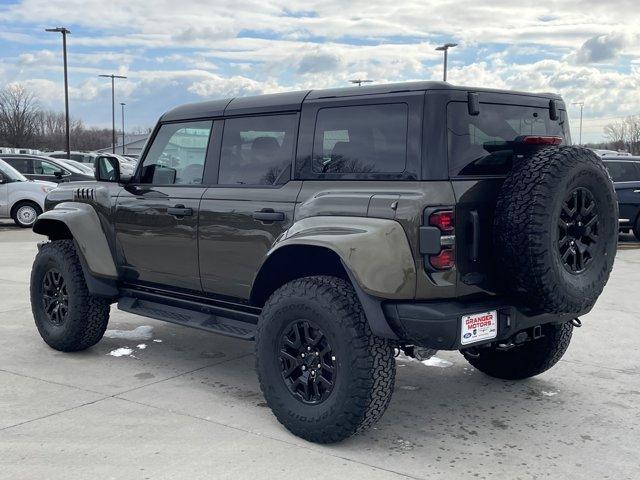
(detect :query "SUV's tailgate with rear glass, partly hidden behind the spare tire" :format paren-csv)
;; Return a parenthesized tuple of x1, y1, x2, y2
(438, 93, 570, 295)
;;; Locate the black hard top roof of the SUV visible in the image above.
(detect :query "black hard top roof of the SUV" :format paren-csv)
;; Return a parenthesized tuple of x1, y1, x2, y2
(160, 81, 560, 122)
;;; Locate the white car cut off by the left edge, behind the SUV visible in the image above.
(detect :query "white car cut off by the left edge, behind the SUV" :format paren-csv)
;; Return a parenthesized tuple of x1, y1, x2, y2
(0, 160, 58, 228)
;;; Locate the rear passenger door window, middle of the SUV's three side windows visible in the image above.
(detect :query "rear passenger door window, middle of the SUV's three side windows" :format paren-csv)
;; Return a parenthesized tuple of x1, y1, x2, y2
(218, 115, 297, 185)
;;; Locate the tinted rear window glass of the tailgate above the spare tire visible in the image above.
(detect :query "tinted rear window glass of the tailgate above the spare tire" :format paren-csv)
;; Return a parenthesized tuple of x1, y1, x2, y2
(447, 102, 568, 177)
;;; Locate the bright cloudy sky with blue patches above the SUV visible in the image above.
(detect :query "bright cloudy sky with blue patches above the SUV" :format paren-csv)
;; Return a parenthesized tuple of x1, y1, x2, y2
(0, 0, 640, 140)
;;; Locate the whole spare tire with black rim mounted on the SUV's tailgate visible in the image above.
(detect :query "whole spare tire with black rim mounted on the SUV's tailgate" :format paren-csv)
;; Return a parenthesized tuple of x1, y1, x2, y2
(493, 146, 618, 315)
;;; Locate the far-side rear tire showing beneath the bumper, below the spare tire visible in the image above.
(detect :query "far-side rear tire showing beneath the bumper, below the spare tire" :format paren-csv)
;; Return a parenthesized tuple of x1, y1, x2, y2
(462, 322, 573, 380)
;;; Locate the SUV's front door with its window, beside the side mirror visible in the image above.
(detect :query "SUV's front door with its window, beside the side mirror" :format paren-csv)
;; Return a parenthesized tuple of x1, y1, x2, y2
(116, 120, 214, 292)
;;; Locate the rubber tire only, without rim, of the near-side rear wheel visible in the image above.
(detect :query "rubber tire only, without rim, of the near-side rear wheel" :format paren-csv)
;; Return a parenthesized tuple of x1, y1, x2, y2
(256, 276, 395, 443)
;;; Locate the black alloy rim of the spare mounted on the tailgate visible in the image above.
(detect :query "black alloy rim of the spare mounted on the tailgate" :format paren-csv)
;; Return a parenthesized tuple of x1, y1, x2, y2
(558, 187, 599, 275)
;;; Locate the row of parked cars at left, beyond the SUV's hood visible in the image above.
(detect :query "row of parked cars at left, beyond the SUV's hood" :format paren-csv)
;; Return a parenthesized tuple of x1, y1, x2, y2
(0, 152, 137, 228)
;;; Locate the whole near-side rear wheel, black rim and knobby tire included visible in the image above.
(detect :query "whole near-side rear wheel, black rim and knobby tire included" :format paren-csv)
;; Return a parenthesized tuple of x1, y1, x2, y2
(256, 276, 395, 443)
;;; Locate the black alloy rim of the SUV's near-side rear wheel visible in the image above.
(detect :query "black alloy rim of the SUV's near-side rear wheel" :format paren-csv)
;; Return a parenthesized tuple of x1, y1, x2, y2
(278, 320, 337, 405)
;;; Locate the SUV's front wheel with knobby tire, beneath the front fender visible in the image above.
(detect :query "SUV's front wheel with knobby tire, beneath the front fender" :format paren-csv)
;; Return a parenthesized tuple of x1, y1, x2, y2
(31, 240, 109, 352)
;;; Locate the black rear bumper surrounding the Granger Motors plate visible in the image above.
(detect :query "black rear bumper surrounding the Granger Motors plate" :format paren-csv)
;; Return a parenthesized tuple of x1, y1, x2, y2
(382, 298, 578, 350)
